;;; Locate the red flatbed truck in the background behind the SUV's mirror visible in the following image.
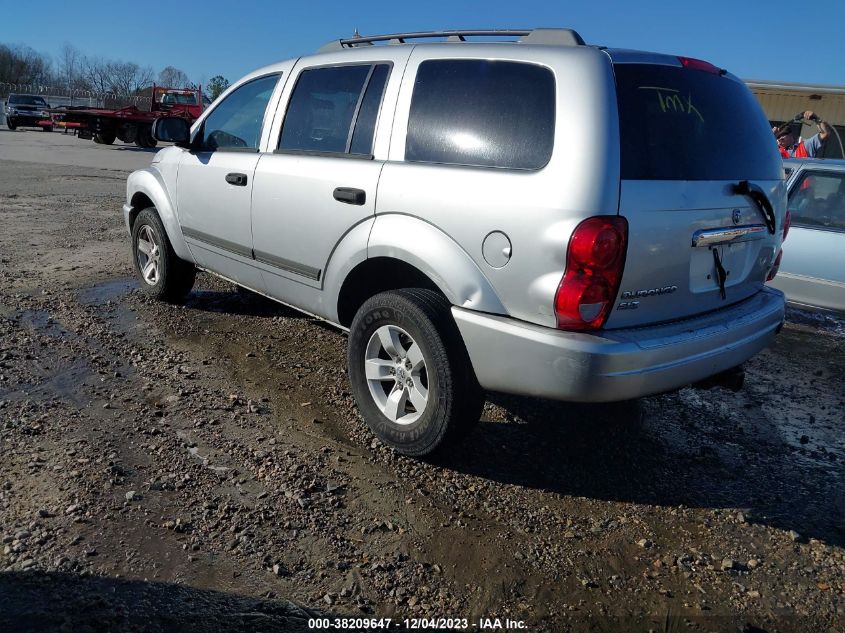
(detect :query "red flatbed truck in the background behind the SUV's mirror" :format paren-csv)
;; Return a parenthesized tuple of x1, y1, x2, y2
(53, 85, 210, 147)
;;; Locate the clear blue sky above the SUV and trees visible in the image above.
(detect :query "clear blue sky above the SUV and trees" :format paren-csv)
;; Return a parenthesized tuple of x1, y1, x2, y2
(0, 0, 845, 86)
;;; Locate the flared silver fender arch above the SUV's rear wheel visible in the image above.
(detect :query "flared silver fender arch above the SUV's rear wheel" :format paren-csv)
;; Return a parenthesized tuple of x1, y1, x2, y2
(367, 214, 507, 314)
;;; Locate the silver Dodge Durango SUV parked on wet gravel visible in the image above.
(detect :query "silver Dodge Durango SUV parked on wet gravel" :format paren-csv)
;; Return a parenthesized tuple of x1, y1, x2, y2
(124, 29, 786, 455)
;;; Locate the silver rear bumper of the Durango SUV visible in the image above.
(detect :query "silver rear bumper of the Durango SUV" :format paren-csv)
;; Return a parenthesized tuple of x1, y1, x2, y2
(452, 288, 784, 402)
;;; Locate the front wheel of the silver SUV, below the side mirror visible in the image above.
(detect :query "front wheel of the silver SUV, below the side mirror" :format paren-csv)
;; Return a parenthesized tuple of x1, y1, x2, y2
(132, 207, 197, 303)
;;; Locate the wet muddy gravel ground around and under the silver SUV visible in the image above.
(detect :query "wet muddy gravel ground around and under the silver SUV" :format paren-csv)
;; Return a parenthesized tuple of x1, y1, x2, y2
(0, 154, 845, 632)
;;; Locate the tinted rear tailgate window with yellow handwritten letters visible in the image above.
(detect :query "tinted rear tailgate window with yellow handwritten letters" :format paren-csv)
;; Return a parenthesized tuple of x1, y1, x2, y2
(614, 64, 783, 180)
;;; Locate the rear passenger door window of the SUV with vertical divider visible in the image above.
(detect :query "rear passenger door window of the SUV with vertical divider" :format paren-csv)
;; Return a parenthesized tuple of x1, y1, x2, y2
(277, 64, 390, 156)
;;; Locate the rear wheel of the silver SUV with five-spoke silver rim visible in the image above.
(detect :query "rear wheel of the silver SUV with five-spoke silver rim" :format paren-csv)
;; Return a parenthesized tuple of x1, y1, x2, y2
(347, 288, 484, 457)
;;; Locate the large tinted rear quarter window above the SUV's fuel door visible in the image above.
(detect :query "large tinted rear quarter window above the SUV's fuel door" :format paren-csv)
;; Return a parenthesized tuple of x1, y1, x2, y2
(405, 59, 555, 169)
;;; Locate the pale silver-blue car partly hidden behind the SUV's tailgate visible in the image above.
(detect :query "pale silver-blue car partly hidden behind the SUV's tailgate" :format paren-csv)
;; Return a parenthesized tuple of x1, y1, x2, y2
(770, 159, 845, 314)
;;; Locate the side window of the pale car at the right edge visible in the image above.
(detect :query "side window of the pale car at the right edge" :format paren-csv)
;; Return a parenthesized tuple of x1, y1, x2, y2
(788, 170, 845, 231)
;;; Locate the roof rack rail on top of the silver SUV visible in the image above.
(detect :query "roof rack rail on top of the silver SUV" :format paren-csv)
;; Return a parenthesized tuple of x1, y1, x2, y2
(317, 29, 584, 53)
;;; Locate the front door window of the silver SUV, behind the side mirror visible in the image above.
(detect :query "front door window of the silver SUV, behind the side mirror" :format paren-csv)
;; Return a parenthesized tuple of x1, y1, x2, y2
(200, 75, 279, 151)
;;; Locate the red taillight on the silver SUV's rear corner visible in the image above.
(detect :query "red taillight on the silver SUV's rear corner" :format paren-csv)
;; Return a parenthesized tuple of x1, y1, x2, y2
(555, 215, 628, 330)
